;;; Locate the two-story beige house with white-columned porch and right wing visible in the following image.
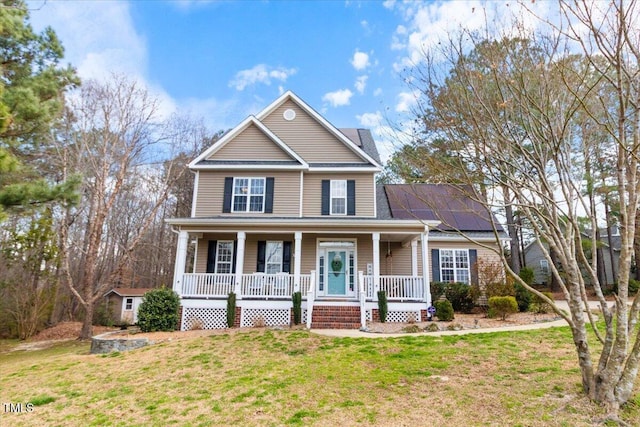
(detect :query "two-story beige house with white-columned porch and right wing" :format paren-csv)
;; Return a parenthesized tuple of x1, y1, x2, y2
(168, 92, 508, 330)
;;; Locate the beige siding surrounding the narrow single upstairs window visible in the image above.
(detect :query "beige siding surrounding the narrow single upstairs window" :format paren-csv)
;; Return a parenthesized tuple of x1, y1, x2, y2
(302, 173, 375, 217)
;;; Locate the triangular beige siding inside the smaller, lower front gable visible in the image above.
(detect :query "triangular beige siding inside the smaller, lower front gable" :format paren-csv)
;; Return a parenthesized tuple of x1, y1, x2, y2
(207, 125, 292, 161)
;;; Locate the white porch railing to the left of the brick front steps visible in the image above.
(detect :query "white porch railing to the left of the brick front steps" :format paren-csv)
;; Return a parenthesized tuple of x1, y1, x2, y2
(182, 273, 311, 299)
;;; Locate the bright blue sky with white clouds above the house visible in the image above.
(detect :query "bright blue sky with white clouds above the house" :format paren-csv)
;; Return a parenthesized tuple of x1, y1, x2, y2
(28, 0, 549, 160)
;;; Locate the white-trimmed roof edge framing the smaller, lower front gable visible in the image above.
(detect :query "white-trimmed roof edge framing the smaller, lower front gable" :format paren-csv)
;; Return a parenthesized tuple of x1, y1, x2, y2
(189, 116, 309, 169)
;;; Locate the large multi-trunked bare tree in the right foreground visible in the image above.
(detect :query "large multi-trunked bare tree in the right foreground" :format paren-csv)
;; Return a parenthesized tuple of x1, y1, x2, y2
(402, 0, 640, 419)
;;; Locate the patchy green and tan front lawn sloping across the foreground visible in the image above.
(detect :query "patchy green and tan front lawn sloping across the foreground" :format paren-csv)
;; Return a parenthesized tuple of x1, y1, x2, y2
(0, 328, 640, 426)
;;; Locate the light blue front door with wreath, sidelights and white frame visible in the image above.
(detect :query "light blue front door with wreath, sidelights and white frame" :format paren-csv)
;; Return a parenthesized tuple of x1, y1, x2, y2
(317, 241, 356, 297)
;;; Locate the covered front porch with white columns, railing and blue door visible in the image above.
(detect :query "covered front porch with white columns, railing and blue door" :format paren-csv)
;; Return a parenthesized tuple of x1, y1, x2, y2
(168, 220, 440, 328)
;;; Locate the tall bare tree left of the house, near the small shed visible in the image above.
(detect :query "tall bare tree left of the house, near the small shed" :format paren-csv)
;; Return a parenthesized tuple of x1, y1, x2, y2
(53, 76, 190, 339)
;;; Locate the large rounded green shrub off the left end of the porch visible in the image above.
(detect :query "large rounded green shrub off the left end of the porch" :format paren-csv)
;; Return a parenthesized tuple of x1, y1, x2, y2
(138, 286, 180, 332)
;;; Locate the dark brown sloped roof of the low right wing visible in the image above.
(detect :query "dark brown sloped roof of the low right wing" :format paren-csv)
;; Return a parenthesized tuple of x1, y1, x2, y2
(378, 184, 503, 232)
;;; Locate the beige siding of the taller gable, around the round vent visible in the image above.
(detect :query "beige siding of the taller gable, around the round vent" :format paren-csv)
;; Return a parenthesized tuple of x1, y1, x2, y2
(262, 100, 367, 163)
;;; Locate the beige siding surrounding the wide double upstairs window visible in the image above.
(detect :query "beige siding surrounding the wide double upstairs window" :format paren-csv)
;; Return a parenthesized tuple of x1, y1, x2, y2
(195, 171, 300, 217)
